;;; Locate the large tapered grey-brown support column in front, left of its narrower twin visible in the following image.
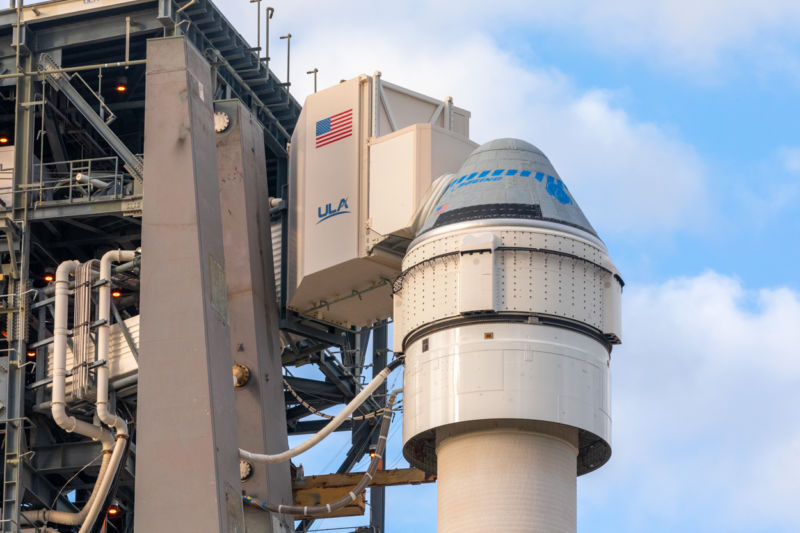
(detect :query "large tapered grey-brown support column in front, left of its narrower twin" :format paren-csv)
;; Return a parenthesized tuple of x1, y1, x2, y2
(135, 37, 245, 533)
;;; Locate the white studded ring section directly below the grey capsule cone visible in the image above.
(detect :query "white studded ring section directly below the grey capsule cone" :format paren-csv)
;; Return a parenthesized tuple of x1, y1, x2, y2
(394, 221, 622, 347)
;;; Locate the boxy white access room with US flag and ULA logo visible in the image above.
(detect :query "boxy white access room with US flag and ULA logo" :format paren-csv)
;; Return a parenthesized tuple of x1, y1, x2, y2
(288, 74, 476, 326)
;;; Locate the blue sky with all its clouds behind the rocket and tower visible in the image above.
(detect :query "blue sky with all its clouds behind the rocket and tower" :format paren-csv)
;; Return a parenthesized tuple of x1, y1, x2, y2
(220, 0, 800, 533)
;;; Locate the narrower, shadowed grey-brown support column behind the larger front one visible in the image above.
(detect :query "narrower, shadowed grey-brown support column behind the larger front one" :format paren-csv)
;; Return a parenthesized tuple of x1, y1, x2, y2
(215, 100, 294, 533)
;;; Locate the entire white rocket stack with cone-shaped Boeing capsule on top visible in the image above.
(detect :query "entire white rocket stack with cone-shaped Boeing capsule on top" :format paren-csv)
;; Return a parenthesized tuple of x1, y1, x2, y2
(394, 139, 622, 533)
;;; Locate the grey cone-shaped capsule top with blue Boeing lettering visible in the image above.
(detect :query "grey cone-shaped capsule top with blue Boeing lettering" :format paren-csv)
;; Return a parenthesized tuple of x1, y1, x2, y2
(420, 139, 597, 237)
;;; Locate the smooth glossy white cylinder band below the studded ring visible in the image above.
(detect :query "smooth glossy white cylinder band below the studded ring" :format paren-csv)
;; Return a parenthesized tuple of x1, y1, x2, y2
(403, 322, 611, 445)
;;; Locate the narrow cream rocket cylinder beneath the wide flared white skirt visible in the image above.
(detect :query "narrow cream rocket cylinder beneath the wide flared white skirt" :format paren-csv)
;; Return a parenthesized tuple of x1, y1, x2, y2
(436, 428, 578, 533)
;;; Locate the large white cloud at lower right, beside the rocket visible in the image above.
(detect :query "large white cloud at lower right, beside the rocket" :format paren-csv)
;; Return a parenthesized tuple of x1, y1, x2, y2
(581, 272, 800, 531)
